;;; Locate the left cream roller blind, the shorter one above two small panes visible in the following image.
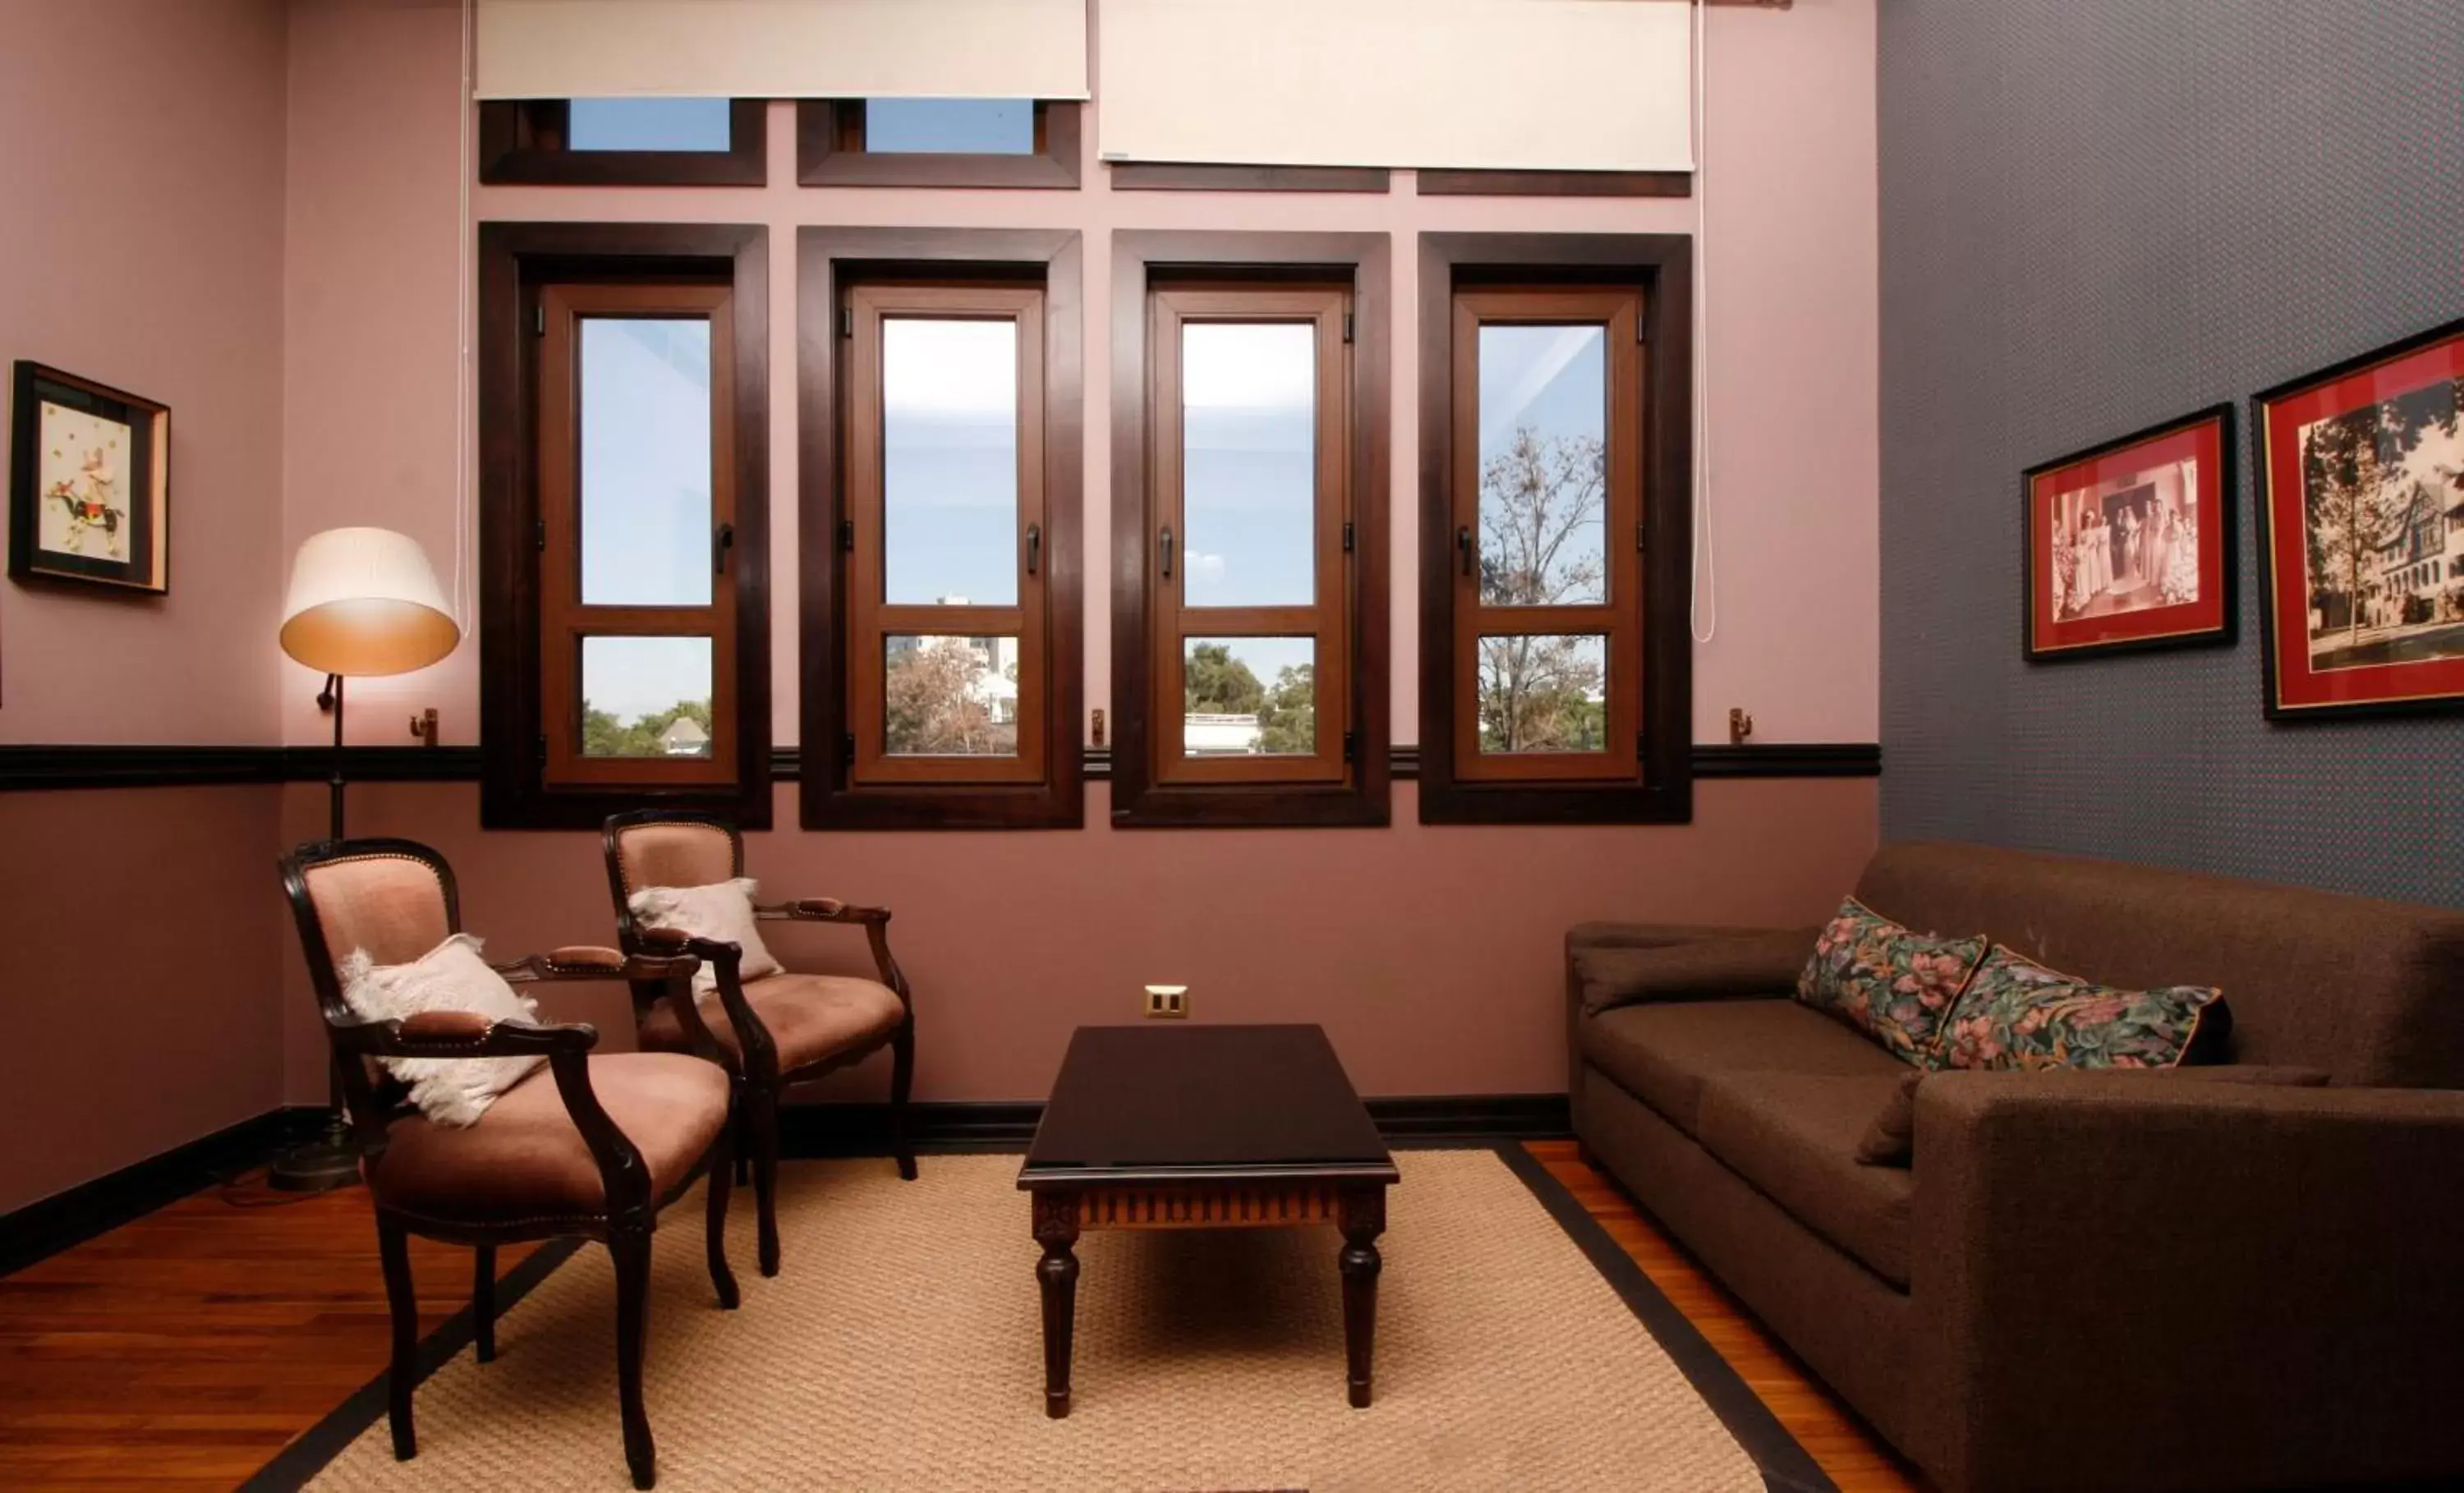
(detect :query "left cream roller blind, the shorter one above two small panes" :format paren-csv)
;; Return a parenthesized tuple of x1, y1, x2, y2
(476, 0, 1087, 99)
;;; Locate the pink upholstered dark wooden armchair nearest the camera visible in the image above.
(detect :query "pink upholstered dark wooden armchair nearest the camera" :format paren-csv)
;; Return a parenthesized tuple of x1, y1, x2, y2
(281, 840, 737, 1488)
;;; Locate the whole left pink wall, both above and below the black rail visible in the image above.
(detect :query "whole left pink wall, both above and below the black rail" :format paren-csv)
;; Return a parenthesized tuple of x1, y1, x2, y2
(0, 0, 286, 1212)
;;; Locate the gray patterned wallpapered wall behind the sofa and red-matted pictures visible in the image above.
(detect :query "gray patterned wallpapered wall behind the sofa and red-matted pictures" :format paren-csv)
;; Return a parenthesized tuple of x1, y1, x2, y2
(1873, 0, 2464, 904)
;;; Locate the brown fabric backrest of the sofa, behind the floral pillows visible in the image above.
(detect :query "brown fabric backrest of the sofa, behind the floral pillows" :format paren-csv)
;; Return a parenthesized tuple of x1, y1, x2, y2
(1858, 845, 2464, 1089)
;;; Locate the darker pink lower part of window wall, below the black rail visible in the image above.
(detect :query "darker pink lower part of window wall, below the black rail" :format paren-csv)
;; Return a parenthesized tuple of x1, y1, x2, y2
(283, 779, 1875, 1101)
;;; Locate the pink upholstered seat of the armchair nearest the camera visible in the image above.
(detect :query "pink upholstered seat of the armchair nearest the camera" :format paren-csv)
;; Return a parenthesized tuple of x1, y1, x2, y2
(365, 1052, 727, 1227)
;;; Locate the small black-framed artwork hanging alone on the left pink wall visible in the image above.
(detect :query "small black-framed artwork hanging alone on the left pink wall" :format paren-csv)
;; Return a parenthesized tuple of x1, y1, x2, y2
(7, 360, 170, 596)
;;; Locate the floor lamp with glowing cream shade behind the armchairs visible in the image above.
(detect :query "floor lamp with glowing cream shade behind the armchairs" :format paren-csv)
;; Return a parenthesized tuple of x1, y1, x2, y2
(269, 530, 461, 1192)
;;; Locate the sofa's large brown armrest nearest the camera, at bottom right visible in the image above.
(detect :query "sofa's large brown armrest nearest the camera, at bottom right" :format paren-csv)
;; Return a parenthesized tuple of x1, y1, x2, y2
(1907, 1072, 2464, 1488)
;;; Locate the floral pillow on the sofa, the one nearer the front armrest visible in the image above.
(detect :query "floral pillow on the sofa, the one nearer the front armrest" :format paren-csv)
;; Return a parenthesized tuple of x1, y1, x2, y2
(1934, 944, 2232, 1069)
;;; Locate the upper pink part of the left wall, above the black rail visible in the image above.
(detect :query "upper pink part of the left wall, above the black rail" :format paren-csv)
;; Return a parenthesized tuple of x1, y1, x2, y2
(0, 0, 283, 744)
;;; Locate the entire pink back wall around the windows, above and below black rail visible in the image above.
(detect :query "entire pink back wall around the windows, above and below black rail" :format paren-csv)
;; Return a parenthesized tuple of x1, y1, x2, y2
(281, 0, 1878, 1099)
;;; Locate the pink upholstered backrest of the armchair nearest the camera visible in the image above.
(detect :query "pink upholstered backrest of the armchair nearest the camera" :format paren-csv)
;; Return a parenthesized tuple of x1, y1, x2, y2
(281, 840, 461, 1123)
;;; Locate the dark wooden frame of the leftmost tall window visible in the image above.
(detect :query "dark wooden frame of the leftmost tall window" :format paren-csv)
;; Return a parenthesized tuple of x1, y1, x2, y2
(478, 222, 771, 830)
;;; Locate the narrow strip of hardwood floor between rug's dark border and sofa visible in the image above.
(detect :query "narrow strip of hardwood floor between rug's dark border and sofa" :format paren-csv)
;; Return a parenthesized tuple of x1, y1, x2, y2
(1523, 1141, 1927, 1493)
